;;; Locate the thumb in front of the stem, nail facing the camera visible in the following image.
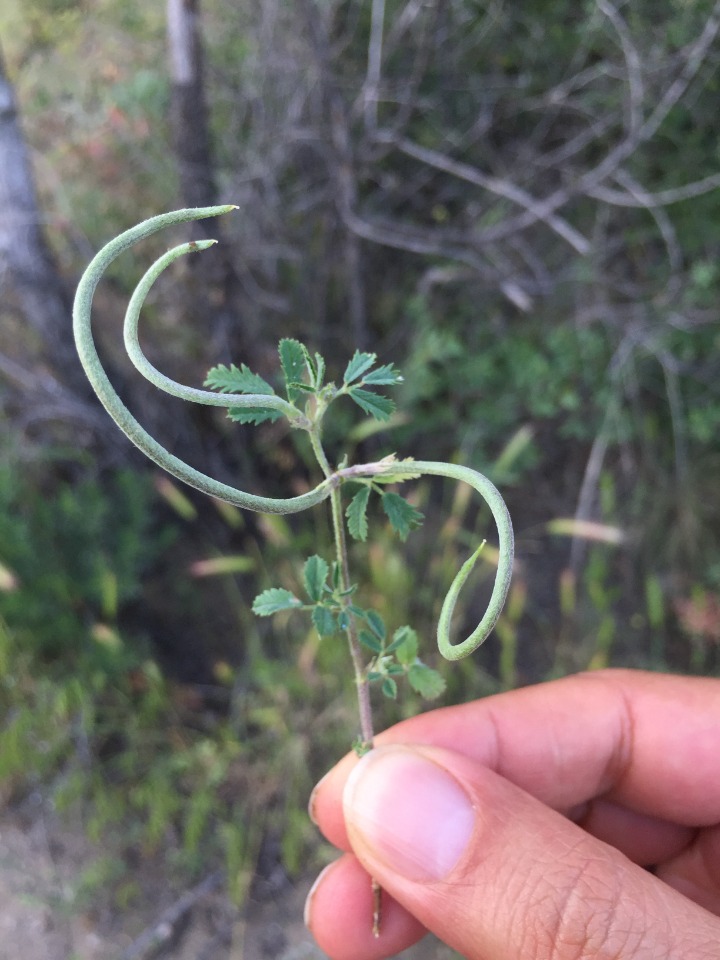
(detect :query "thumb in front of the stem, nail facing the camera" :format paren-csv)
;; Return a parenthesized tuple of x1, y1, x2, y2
(343, 746, 720, 960)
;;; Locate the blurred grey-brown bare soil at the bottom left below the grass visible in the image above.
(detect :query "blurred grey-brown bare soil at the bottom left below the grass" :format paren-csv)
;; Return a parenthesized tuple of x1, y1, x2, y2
(0, 812, 457, 960)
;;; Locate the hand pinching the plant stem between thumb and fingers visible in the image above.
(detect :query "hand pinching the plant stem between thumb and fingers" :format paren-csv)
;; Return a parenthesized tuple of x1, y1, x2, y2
(306, 671, 720, 960)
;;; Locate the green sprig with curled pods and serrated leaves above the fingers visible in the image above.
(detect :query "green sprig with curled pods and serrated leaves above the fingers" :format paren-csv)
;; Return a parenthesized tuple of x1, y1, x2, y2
(73, 206, 513, 750)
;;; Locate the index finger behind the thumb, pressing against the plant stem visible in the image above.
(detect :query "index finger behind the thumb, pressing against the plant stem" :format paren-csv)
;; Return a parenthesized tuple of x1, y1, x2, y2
(311, 670, 720, 848)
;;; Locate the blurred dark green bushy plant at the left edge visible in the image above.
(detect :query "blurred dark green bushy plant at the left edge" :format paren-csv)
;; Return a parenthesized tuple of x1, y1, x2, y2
(0, 468, 166, 669)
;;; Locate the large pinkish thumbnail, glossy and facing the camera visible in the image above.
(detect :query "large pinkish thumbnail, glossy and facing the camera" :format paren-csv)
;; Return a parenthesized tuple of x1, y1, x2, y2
(343, 746, 475, 882)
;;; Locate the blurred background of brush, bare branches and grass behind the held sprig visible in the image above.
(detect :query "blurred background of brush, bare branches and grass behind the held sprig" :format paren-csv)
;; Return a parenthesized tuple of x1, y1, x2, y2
(0, 0, 720, 960)
